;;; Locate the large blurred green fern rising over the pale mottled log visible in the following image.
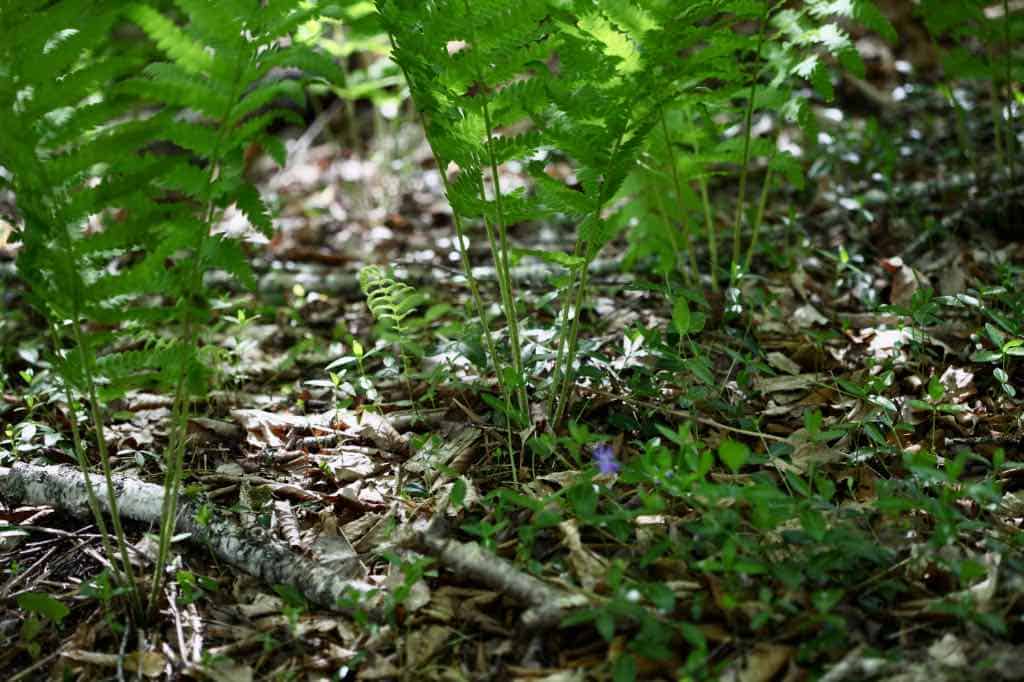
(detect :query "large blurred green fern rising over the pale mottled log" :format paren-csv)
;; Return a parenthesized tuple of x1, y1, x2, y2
(0, 0, 342, 608)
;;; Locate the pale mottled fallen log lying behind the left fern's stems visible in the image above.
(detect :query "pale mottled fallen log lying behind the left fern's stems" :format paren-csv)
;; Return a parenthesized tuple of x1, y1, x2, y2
(0, 463, 381, 614)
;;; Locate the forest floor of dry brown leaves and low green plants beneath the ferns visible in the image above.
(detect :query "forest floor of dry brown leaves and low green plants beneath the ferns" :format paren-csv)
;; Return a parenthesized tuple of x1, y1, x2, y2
(0, 51, 1024, 682)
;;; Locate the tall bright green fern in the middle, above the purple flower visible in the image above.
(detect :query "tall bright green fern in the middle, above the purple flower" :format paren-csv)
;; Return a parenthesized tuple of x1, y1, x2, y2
(378, 0, 664, 422)
